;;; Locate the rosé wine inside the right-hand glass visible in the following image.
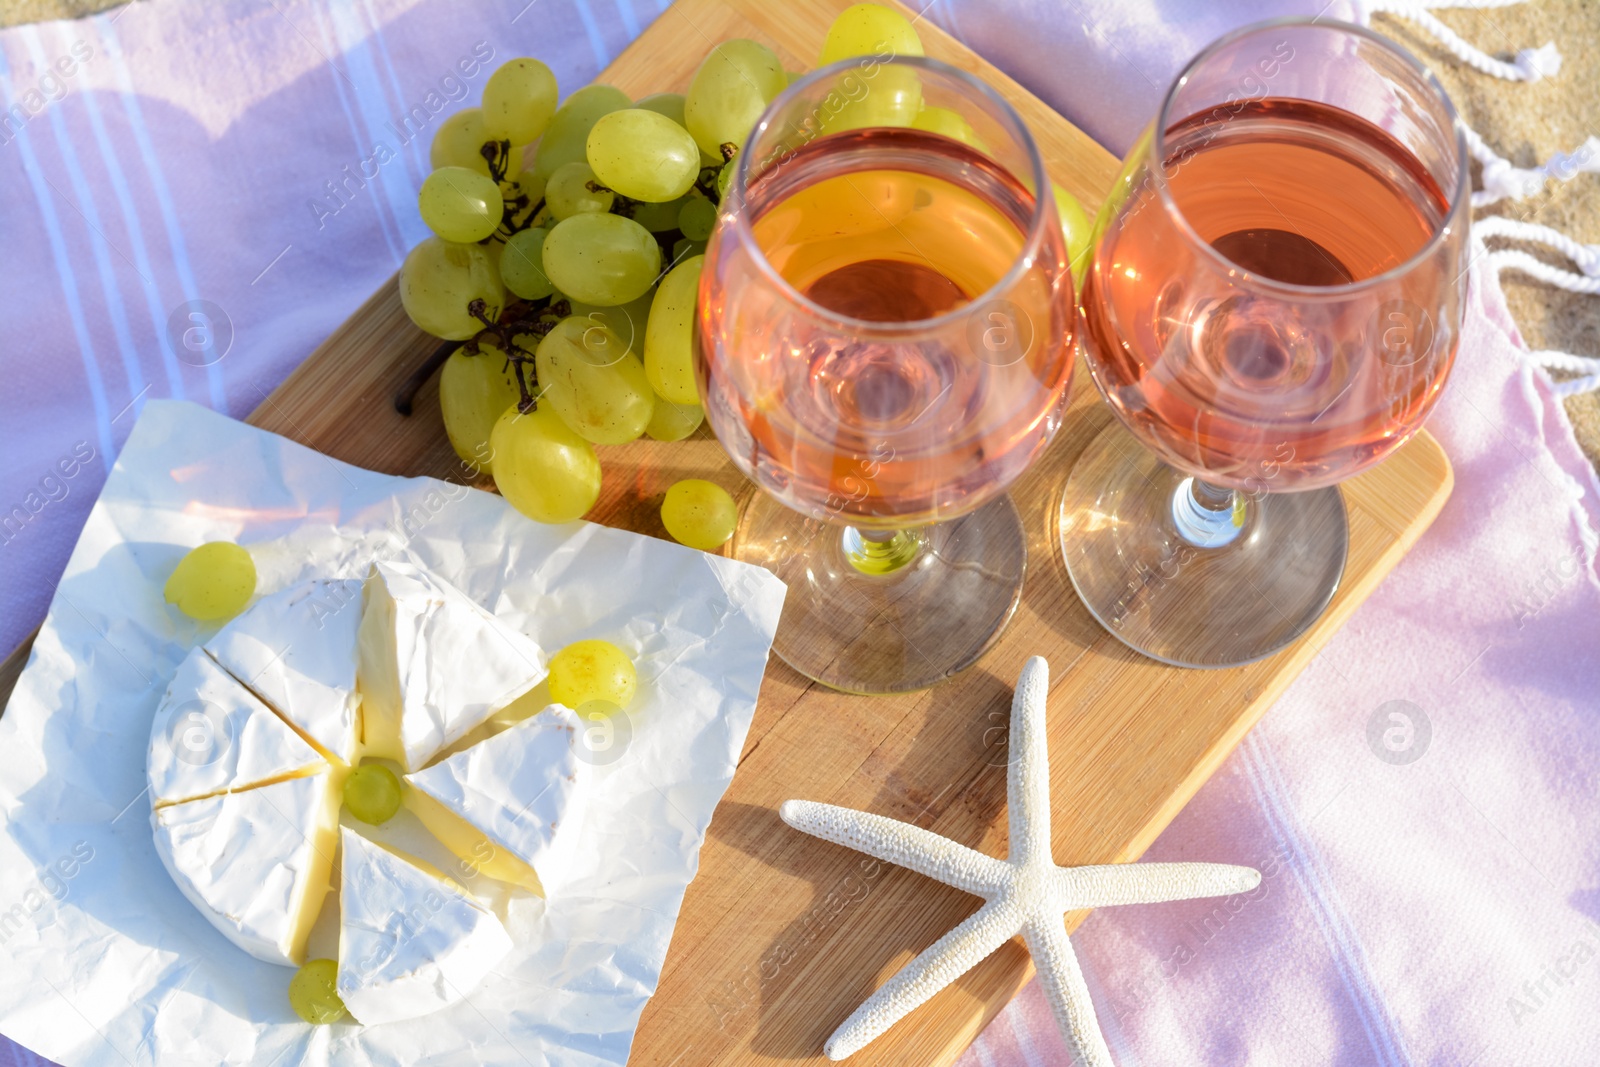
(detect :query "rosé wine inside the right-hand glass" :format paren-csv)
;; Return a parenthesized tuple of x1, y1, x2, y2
(1083, 99, 1462, 491)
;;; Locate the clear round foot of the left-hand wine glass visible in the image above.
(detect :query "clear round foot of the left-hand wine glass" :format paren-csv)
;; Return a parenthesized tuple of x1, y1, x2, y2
(733, 494, 1027, 693)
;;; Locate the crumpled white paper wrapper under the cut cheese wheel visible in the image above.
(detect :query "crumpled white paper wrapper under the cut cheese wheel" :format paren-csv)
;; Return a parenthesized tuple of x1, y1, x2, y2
(0, 402, 784, 1067)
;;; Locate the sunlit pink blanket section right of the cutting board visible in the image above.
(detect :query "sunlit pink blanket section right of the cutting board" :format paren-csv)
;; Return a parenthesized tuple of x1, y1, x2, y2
(960, 259, 1600, 1067)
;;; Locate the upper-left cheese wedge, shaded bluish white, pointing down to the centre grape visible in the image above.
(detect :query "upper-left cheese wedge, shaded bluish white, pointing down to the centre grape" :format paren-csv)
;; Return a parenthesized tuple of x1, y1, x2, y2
(205, 579, 362, 763)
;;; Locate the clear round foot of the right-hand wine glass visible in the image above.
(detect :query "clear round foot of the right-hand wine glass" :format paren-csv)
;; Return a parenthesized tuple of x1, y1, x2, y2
(1061, 422, 1349, 667)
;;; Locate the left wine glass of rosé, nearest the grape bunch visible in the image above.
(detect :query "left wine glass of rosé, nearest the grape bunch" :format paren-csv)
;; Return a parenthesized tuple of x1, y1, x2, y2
(696, 56, 1075, 693)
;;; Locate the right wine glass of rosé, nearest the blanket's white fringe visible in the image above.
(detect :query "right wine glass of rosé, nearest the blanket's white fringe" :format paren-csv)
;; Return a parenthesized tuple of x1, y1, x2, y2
(1061, 19, 1469, 667)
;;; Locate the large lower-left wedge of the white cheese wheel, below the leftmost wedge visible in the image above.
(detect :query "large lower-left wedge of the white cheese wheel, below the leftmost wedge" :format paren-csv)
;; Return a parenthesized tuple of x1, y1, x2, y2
(150, 768, 344, 966)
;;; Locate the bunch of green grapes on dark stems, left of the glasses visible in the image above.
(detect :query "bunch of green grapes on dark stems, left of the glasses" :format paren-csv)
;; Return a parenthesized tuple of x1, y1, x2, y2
(397, 58, 723, 522)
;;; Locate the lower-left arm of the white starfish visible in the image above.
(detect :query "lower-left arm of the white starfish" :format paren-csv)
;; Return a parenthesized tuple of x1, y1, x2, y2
(822, 902, 1022, 1059)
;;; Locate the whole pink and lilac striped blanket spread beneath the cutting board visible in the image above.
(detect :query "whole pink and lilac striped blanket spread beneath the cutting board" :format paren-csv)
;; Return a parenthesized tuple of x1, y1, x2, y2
(0, 0, 1600, 1067)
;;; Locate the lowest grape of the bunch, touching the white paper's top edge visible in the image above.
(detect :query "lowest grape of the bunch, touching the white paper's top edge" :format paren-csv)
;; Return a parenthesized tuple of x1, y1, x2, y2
(490, 403, 600, 523)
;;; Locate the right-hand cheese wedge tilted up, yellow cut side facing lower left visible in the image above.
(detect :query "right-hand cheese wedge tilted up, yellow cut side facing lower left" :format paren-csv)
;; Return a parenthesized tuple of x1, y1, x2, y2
(405, 704, 590, 896)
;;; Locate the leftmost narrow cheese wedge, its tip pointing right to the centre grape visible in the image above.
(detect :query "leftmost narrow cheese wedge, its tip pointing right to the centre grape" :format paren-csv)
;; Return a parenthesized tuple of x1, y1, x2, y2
(146, 648, 328, 806)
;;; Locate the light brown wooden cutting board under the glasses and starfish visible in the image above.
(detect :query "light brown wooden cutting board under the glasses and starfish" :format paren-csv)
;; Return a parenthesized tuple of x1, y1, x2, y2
(0, 0, 1451, 1067)
